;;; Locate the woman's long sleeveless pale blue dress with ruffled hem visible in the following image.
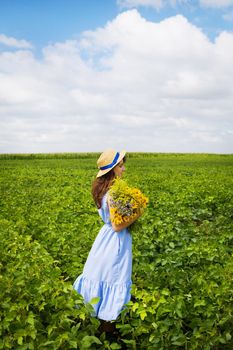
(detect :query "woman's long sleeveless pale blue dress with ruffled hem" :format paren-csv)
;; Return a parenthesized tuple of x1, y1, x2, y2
(73, 194, 132, 321)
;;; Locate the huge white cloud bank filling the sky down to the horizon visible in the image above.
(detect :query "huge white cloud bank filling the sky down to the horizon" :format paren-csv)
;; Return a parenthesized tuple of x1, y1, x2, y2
(0, 10, 233, 153)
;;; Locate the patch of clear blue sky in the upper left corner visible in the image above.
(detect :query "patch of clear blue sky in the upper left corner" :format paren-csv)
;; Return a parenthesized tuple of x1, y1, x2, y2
(0, 0, 119, 48)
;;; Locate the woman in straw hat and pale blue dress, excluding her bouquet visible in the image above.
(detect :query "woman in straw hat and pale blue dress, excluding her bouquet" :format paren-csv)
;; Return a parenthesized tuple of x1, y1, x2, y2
(74, 149, 141, 321)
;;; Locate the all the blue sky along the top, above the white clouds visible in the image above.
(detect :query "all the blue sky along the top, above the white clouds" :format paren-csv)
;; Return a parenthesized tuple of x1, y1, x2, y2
(0, 0, 233, 49)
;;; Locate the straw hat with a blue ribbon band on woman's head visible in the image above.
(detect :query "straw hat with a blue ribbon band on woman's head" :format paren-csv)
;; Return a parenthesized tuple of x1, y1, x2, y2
(96, 149, 126, 177)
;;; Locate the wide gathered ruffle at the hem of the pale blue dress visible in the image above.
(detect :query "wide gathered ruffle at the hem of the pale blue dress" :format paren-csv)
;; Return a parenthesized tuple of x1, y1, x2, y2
(73, 274, 132, 321)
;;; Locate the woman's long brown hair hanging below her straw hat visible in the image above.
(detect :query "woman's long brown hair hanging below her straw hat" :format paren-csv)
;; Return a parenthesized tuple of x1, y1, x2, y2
(92, 156, 126, 209)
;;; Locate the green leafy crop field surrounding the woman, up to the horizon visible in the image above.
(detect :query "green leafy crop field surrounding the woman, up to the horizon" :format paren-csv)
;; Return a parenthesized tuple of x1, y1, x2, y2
(0, 153, 233, 350)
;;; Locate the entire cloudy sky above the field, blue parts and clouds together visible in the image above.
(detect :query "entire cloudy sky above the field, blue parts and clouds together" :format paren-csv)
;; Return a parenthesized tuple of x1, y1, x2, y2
(0, 0, 233, 153)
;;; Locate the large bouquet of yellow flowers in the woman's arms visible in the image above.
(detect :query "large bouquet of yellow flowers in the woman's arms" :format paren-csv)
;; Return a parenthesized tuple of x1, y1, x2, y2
(109, 178, 148, 225)
